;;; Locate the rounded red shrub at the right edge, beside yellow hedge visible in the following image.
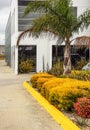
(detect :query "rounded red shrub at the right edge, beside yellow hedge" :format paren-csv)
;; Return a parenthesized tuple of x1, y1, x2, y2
(74, 97, 90, 118)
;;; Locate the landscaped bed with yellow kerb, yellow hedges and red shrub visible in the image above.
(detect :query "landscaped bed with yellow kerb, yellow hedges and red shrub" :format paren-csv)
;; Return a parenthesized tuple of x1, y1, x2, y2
(24, 72, 90, 130)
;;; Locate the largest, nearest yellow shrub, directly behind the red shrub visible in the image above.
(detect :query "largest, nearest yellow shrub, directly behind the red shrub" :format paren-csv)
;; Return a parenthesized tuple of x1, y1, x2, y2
(49, 80, 90, 110)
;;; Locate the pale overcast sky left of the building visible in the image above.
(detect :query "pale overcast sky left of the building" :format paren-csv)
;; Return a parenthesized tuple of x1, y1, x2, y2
(0, 0, 11, 44)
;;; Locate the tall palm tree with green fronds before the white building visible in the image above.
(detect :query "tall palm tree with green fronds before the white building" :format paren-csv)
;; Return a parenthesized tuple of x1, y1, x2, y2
(17, 0, 90, 74)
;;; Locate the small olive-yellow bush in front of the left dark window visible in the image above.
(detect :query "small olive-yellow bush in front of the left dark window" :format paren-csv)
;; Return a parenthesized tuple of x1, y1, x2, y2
(19, 59, 33, 73)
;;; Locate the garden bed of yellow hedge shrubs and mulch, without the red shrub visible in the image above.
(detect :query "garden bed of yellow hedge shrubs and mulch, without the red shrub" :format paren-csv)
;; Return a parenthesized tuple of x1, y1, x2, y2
(27, 73, 90, 130)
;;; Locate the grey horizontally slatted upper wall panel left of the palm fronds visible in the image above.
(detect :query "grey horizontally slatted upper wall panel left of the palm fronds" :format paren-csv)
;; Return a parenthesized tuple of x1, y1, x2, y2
(18, 0, 41, 31)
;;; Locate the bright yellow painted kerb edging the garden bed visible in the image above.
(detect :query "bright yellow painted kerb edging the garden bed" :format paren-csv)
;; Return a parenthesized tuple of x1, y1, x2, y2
(23, 82, 80, 130)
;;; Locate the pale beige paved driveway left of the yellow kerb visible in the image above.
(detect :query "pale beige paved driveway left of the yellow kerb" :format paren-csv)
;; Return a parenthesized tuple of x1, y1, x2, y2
(0, 61, 62, 130)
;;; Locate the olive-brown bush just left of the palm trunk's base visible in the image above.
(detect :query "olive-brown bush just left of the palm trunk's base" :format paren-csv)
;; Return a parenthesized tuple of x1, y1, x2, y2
(48, 61, 63, 77)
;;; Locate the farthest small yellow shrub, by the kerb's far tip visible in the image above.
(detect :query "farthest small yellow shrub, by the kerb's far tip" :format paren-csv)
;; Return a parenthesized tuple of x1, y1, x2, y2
(30, 72, 54, 88)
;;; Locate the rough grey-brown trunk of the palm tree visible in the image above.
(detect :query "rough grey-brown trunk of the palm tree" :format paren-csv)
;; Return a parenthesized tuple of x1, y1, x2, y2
(63, 42, 71, 75)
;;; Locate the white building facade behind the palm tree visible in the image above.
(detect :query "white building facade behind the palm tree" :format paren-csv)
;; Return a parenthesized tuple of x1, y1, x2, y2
(5, 0, 90, 74)
